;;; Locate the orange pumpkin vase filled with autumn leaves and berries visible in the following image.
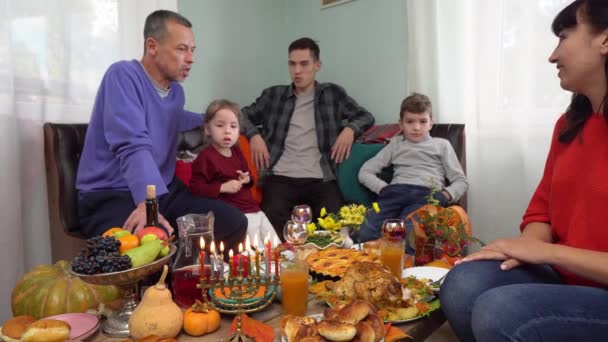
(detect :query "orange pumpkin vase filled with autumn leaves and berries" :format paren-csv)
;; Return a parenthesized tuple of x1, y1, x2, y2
(405, 184, 485, 264)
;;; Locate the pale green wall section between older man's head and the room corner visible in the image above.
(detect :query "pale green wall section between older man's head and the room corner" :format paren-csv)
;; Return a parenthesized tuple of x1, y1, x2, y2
(178, 0, 289, 112)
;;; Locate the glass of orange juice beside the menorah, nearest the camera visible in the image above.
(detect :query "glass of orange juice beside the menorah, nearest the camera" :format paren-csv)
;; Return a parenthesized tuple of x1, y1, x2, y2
(279, 259, 308, 316)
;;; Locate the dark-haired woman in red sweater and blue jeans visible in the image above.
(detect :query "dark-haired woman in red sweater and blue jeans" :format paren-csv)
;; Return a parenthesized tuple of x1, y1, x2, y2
(440, 0, 608, 341)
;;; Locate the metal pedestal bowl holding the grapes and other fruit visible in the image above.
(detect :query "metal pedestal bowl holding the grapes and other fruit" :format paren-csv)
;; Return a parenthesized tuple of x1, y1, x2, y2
(70, 244, 177, 338)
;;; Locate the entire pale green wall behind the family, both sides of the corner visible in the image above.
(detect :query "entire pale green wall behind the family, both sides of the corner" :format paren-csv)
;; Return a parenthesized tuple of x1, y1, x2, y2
(178, 0, 407, 123)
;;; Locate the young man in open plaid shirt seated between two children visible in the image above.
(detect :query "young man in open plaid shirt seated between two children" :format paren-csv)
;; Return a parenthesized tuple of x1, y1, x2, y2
(243, 38, 374, 236)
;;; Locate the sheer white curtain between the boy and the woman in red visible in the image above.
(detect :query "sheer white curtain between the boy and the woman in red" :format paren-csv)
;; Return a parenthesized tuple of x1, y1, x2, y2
(407, 0, 571, 246)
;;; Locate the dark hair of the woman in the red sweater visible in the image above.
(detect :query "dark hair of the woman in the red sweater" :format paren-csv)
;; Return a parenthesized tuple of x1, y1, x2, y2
(551, 0, 608, 143)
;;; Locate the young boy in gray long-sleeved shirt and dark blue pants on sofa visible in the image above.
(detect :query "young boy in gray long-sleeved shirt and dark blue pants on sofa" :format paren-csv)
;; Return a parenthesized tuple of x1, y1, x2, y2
(359, 93, 469, 246)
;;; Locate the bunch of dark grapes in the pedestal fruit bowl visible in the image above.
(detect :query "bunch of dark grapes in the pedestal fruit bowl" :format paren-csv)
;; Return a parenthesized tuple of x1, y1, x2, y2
(72, 236, 131, 275)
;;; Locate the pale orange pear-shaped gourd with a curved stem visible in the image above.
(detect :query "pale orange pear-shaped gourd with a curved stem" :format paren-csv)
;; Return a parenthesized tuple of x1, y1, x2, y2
(129, 265, 184, 339)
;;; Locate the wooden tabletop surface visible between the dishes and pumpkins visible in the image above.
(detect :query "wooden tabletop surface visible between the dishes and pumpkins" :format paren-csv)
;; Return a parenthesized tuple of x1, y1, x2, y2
(90, 296, 445, 342)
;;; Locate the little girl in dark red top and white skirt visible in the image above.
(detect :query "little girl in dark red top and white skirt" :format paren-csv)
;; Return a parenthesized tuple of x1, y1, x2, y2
(190, 100, 278, 239)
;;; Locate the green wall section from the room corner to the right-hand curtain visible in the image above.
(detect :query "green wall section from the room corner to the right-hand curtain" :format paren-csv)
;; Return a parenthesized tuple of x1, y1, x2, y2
(286, 0, 407, 123)
